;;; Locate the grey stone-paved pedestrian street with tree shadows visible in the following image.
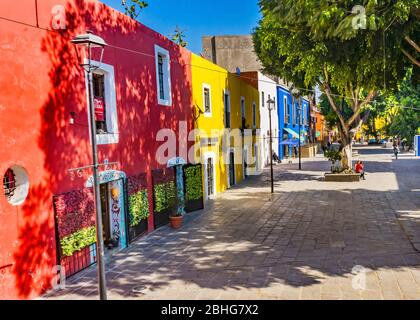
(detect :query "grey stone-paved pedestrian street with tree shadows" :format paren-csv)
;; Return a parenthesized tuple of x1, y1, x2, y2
(45, 147, 420, 300)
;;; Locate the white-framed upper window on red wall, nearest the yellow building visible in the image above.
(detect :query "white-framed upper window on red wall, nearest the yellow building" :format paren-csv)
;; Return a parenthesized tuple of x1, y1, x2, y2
(155, 46, 172, 106)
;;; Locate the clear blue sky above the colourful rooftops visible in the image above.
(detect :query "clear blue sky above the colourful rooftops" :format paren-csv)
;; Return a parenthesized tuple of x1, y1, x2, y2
(101, 0, 260, 53)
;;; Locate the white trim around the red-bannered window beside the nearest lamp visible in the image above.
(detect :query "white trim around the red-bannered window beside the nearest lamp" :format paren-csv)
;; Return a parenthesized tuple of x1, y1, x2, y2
(85, 59, 119, 145)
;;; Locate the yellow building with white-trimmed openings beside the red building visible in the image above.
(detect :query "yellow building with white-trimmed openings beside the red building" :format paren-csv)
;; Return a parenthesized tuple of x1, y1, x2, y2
(191, 54, 260, 199)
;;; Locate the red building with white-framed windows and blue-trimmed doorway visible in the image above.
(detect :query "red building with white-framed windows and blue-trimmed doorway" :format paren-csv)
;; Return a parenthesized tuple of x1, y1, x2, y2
(0, 0, 193, 299)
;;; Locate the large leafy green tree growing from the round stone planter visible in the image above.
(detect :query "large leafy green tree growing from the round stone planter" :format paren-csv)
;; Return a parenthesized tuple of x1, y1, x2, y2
(254, 0, 420, 167)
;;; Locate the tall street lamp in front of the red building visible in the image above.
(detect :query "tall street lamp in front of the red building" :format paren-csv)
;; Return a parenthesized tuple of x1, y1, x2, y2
(71, 31, 107, 300)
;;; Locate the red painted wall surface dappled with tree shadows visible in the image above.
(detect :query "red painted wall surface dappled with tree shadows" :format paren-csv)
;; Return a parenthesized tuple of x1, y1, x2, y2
(0, 0, 193, 299)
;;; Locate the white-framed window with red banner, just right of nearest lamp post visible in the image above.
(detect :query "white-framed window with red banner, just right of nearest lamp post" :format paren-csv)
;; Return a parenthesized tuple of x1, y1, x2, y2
(86, 61, 119, 145)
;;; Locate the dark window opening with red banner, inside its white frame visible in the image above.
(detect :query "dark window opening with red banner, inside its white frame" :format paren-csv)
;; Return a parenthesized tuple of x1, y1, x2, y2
(93, 73, 107, 134)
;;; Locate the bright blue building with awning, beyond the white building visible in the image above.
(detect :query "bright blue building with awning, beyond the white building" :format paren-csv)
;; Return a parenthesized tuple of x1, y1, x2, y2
(277, 86, 310, 160)
